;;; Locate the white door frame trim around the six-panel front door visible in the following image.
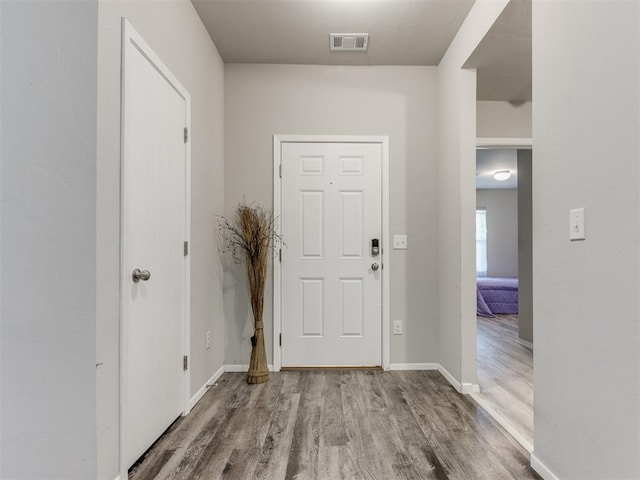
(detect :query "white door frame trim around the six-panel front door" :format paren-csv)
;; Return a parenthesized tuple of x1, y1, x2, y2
(273, 135, 391, 372)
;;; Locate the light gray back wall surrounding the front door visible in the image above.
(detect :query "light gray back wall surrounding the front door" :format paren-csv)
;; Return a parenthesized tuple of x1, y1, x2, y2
(225, 64, 438, 364)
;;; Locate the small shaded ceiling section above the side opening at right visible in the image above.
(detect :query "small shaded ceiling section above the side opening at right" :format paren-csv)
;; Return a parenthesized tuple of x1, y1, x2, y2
(465, 0, 532, 103)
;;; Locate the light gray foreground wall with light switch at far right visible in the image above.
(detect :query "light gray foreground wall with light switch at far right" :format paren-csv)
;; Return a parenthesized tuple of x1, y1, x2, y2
(533, 0, 640, 480)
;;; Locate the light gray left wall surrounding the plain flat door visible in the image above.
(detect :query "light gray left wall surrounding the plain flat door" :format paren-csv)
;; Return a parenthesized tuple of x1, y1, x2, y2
(97, 0, 225, 479)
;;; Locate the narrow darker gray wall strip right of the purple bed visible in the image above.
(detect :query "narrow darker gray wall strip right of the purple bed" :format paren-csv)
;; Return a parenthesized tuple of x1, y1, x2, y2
(518, 150, 533, 343)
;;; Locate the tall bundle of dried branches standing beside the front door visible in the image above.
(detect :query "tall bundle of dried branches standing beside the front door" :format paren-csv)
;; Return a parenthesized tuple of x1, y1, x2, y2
(218, 203, 281, 384)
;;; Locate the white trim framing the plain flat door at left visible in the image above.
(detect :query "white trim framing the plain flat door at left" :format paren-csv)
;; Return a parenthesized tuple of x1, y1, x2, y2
(118, 17, 192, 478)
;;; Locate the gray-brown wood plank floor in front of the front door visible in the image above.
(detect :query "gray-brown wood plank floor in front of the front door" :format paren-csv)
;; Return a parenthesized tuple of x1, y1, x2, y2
(130, 370, 540, 480)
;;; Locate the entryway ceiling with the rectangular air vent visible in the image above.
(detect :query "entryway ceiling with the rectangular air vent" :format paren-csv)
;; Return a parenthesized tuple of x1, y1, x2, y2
(192, 0, 474, 65)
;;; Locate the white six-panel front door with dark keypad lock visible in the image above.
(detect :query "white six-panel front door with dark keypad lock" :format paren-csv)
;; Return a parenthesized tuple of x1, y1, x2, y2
(280, 143, 382, 367)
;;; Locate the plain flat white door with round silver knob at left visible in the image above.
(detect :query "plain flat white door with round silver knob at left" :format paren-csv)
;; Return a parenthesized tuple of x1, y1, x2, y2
(122, 26, 189, 468)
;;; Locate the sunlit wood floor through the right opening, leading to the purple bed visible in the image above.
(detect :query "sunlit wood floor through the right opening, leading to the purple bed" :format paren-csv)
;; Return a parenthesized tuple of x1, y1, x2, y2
(476, 315, 533, 446)
